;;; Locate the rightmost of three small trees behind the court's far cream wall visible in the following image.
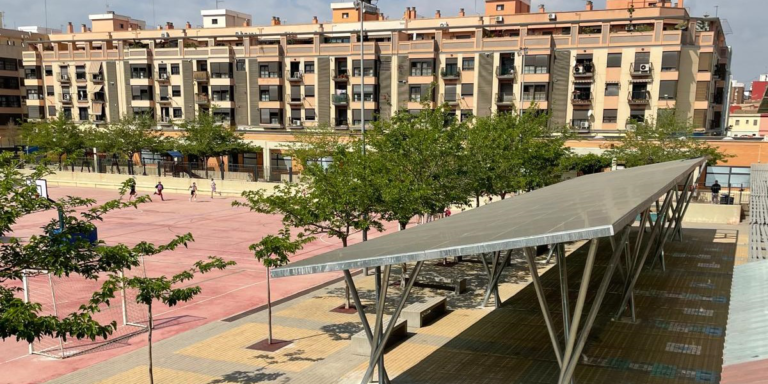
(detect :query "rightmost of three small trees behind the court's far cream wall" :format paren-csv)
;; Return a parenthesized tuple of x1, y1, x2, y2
(178, 112, 259, 179)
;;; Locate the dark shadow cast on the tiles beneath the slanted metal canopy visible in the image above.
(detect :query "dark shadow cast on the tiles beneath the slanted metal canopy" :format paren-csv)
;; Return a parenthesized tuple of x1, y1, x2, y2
(392, 228, 736, 384)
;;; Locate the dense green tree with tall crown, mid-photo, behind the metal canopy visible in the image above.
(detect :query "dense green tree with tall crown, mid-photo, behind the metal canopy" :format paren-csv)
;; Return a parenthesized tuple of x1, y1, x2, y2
(367, 102, 471, 229)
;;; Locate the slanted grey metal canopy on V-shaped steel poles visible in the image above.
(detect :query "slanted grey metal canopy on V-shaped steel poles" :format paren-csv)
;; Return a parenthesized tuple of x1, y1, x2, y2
(272, 159, 706, 384)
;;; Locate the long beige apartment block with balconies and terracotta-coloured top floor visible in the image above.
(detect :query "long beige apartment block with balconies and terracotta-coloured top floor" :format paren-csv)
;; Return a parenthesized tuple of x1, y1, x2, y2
(18, 0, 731, 163)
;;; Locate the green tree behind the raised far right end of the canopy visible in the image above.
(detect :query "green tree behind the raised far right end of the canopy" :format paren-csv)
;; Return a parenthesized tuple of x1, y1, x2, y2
(605, 109, 730, 167)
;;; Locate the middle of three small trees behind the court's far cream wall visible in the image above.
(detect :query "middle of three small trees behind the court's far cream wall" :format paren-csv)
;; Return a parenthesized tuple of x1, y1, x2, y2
(91, 114, 173, 175)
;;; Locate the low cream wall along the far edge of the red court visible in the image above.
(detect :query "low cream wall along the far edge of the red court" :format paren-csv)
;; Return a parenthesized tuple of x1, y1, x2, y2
(22, 171, 277, 196)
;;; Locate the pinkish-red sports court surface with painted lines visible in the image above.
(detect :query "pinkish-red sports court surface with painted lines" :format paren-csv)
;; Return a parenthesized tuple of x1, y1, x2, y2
(0, 187, 395, 383)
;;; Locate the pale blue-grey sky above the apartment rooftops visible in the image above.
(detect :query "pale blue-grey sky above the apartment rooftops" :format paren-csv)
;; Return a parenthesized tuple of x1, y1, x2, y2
(0, 0, 768, 83)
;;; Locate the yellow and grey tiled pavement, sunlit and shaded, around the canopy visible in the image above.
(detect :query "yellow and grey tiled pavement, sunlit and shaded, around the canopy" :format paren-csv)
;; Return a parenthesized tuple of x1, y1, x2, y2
(45, 225, 741, 384)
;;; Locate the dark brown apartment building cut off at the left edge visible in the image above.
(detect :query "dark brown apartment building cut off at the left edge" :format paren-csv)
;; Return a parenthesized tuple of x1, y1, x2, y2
(0, 28, 43, 147)
